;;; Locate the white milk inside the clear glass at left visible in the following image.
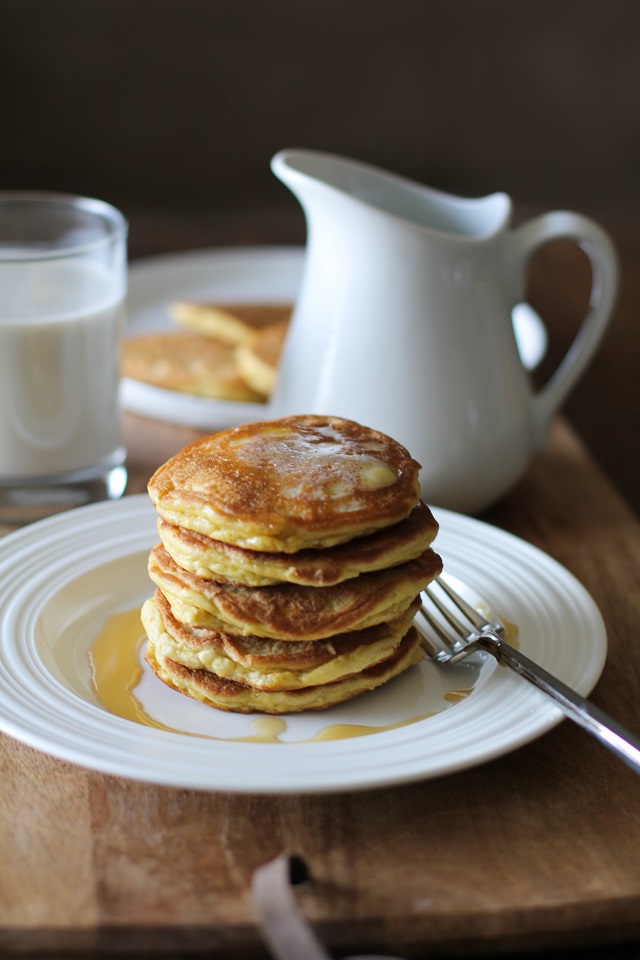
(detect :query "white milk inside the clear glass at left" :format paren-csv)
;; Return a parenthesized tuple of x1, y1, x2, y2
(0, 259, 124, 483)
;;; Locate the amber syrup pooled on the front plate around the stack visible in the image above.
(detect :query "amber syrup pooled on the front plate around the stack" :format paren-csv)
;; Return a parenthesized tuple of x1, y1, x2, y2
(89, 609, 471, 743)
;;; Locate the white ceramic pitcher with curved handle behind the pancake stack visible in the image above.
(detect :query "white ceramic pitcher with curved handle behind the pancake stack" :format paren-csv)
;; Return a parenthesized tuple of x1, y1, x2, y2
(271, 150, 617, 513)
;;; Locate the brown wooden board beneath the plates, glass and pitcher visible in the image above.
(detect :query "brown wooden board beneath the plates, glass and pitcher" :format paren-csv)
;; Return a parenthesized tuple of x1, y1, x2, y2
(0, 408, 640, 960)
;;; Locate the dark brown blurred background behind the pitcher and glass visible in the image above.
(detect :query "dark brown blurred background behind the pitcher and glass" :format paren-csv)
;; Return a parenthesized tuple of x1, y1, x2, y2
(0, 0, 640, 509)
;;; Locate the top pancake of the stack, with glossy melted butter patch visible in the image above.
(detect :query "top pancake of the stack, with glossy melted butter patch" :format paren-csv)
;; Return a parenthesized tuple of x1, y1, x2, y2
(148, 415, 420, 553)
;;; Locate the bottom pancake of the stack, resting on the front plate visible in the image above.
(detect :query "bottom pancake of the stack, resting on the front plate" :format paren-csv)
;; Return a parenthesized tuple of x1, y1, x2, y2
(145, 627, 422, 714)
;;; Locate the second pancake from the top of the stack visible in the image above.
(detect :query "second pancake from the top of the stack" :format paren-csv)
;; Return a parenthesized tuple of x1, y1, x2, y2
(158, 502, 438, 587)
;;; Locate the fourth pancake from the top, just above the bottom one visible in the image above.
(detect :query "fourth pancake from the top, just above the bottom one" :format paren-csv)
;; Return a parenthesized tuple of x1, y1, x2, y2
(142, 590, 419, 690)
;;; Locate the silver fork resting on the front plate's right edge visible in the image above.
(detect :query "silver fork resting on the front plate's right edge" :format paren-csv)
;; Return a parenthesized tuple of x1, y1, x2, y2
(416, 577, 640, 773)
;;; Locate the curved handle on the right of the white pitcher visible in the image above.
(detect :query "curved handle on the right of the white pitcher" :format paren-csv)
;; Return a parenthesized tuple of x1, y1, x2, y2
(512, 210, 618, 449)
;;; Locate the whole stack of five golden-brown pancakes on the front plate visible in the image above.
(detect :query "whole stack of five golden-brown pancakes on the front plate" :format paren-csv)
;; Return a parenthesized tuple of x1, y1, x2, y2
(142, 416, 442, 714)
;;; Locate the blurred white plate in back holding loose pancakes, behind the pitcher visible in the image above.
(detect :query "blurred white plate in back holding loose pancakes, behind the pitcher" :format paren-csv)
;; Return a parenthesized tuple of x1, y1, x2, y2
(122, 247, 547, 430)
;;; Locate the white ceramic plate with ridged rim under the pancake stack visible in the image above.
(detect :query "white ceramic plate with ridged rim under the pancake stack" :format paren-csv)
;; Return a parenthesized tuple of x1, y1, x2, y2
(0, 494, 606, 793)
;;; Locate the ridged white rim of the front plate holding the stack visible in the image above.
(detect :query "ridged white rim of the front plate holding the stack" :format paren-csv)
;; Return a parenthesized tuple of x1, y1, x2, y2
(0, 494, 607, 794)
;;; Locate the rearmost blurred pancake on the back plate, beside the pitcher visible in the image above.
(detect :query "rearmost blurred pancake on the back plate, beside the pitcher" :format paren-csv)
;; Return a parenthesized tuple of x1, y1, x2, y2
(169, 300, 292, 346)
